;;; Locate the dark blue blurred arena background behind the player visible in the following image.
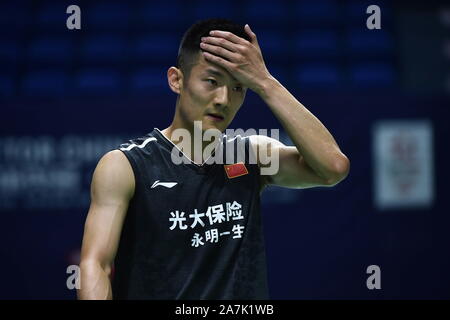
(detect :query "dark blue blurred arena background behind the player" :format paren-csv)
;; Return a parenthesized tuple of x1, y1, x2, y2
(0, 0, 450, 299)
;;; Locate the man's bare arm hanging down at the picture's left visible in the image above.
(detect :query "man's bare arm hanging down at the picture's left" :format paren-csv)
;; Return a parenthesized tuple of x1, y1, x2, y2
(77, 150, 135, 300)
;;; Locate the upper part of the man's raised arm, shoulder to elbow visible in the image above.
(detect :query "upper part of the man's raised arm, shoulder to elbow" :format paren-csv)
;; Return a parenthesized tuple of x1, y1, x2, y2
(249, 135, 342, 190)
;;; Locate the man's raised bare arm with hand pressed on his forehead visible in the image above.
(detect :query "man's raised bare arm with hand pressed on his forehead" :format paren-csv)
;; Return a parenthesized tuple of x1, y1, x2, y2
(202, 25, 350, 188)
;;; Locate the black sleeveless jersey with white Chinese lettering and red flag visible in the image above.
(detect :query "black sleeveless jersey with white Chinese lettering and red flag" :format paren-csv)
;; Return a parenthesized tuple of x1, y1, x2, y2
(112, 128, 269, 299)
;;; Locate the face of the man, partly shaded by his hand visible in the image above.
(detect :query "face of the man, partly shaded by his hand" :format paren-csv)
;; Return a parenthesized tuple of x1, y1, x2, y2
(180, 54, 247, 132)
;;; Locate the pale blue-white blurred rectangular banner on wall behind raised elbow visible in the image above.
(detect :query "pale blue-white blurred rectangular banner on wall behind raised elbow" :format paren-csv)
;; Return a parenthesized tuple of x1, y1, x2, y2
(373, 120, 434, 210)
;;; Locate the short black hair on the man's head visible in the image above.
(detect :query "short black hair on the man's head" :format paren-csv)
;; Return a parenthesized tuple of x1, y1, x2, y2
(177, 18, 251, 79)
